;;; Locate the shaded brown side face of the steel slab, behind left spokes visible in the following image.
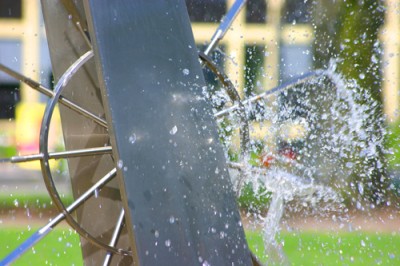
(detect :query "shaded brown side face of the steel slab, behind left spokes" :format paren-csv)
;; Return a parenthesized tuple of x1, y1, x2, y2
(41, 0, 131, 265)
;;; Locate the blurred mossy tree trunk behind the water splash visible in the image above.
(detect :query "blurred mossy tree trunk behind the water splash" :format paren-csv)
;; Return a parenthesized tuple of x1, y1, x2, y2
(313, 0, 388, 204)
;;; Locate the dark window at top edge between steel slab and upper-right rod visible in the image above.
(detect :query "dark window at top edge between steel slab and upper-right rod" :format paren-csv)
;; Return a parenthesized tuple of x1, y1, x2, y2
(186, 0, 226, 22)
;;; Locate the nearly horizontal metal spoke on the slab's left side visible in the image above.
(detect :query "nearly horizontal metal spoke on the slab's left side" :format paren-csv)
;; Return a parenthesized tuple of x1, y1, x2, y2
(0, 146, 112, 163)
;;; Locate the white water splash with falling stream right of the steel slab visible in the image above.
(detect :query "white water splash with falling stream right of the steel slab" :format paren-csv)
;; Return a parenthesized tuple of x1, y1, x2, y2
(212, 59, 386, 264)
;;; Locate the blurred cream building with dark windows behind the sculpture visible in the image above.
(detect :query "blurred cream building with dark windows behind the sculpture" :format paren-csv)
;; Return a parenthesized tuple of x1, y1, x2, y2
(0, 0, 400, 163)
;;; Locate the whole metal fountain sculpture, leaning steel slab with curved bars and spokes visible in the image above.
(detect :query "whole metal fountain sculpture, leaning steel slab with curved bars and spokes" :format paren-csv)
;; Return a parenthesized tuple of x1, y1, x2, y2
(0, 0, 338, 265)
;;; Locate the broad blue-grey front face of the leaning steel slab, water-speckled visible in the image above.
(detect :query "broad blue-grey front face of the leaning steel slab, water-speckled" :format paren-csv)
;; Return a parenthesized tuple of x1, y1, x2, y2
(85, 0, 252, 265)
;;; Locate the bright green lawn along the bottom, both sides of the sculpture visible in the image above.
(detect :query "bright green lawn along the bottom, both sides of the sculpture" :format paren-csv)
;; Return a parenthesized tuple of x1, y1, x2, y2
(0, 228, 400, 265)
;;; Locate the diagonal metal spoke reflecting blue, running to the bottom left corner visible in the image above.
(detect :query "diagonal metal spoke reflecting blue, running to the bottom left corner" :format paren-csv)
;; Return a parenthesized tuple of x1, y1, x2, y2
(0, 168, 117, 265)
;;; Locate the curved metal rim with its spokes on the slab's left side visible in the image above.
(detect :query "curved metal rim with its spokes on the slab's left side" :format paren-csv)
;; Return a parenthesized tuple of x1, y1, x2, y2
(1, 51, 132, 264)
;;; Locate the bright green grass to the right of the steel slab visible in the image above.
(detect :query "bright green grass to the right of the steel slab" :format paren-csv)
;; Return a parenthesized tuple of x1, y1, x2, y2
(247, 232, 400, 265)
